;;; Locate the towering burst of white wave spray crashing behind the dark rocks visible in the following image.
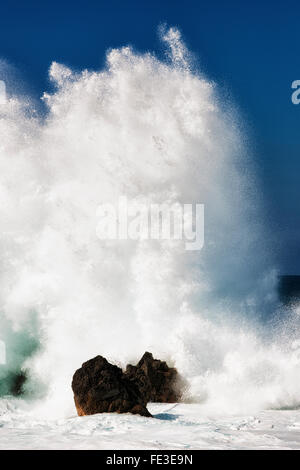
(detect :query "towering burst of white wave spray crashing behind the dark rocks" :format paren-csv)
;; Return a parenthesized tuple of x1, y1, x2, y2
(0, 28, 300, 417)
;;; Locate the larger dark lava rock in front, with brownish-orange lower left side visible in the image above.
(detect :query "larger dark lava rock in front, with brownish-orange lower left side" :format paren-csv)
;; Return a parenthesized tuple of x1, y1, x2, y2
(72, 356, 151, 416)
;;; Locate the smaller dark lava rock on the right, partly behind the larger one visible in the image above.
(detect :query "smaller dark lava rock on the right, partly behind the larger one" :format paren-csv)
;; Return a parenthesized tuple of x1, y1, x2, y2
(124, 352, 185, 403)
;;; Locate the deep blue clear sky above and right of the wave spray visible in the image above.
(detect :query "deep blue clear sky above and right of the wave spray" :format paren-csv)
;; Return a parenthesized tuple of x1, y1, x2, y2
(0, 0, 300, 274)
